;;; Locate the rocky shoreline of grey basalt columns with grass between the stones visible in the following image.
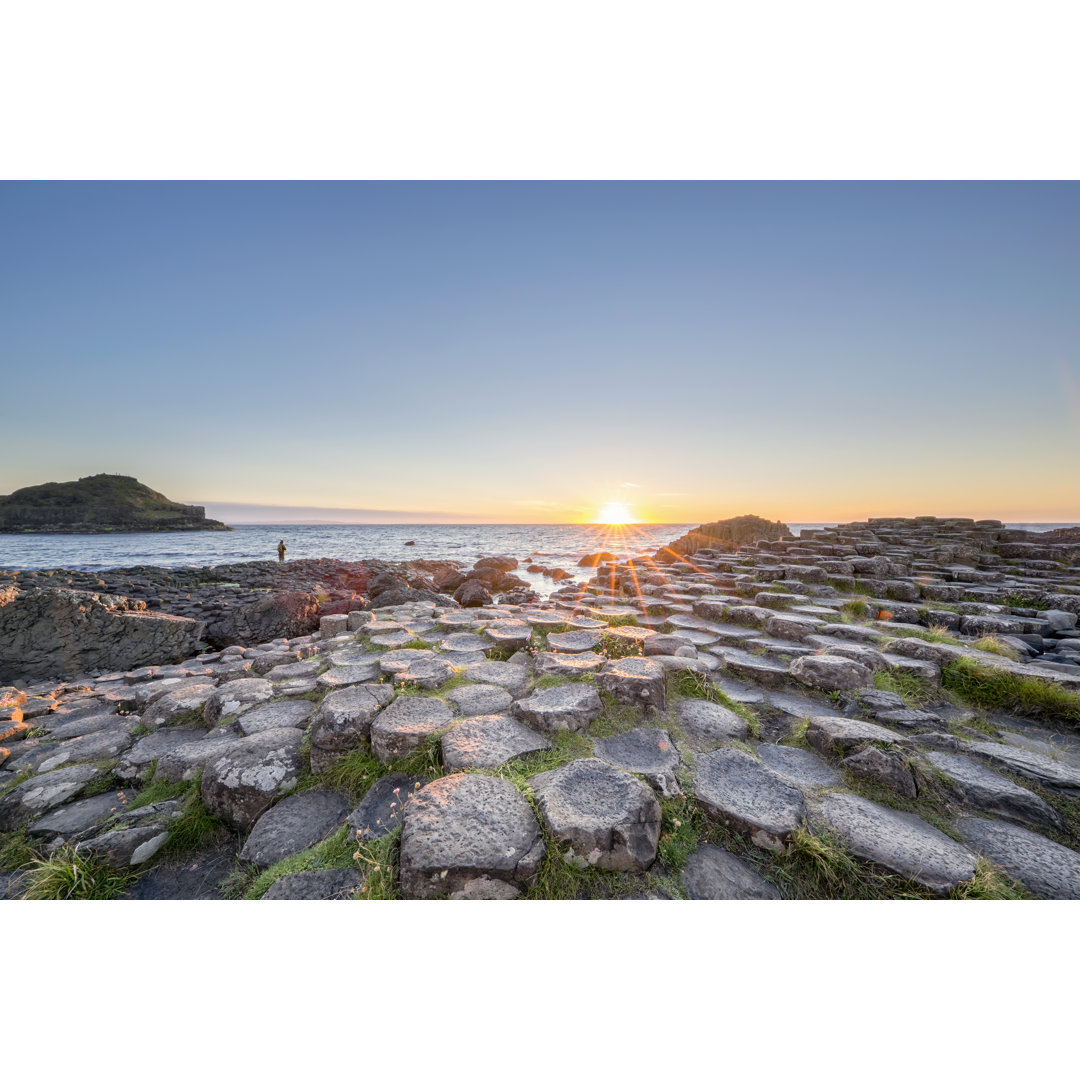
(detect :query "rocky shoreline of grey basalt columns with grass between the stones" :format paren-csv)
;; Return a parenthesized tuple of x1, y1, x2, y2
(0, 517, 1080, 899)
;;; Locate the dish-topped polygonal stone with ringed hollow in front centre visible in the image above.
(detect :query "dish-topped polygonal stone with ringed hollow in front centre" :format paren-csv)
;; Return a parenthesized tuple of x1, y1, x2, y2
(529, 758, 660, 870)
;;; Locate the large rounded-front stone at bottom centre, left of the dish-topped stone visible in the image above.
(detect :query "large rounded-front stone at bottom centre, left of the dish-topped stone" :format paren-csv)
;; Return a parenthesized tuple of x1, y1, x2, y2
(401, 773, 545, 900)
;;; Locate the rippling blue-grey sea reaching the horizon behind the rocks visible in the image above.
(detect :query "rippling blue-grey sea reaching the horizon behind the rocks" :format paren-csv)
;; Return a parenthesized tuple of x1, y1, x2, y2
(0, 522, 1070, 595)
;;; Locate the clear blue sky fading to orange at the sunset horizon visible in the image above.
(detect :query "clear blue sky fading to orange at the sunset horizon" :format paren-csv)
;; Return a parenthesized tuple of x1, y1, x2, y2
(0, 183, 1080, 522)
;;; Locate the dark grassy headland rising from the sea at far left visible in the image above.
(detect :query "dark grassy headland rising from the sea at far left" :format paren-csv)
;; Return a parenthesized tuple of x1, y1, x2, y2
(0, 473, 229, 532)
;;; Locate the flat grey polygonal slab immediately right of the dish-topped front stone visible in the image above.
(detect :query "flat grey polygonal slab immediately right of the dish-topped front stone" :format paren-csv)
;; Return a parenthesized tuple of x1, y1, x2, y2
(693, 748, 806, 851)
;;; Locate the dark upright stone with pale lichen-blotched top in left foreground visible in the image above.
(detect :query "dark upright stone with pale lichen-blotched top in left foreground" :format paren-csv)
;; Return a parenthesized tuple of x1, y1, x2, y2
(202, 728, 303, 829)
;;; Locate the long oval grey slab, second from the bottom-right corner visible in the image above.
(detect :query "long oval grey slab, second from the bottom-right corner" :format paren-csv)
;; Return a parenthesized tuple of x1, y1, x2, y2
(821, 794, 975, 895)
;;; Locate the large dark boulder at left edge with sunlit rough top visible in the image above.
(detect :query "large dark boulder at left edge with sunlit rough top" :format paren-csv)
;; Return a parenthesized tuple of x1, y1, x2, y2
(0, 586, 205, 680)
